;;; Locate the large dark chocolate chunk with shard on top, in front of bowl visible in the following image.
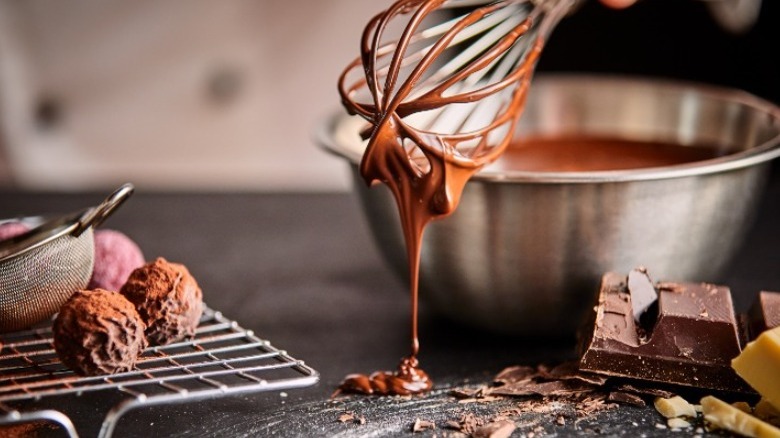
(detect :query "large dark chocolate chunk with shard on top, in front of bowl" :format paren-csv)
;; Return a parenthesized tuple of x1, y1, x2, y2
(580, 273, 752, 392)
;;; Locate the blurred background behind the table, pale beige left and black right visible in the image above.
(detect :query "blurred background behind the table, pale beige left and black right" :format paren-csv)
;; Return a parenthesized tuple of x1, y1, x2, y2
(0, 0, 780, 192)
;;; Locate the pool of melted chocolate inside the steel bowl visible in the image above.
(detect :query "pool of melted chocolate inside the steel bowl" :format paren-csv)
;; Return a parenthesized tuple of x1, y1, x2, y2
(488, 136, 727, 172)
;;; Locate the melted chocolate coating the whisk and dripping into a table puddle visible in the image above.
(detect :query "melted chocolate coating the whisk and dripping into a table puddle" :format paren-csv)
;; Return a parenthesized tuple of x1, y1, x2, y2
(336, 0, 542, 395)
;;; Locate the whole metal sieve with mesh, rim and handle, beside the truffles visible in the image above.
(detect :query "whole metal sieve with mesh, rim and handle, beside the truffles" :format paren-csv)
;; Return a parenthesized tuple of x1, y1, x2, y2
(0, 184, 133, 332)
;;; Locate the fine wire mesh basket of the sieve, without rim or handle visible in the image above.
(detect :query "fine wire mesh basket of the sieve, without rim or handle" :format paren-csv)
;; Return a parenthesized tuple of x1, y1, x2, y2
(0, 228, 94, 332)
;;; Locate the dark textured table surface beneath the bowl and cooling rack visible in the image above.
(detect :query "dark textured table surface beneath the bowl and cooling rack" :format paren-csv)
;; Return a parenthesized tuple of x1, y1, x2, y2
(0, 166, 780, 436)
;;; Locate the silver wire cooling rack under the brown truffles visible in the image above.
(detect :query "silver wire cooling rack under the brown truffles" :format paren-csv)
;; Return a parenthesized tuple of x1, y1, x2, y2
(0, 308, 319, 437)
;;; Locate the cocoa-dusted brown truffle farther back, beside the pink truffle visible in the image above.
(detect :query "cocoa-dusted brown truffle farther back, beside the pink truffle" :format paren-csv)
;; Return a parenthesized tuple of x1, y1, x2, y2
(120, 257, 203, 345)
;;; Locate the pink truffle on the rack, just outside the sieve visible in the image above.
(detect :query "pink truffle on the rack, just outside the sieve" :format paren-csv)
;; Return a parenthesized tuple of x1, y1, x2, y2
(87, 230, 145, 291)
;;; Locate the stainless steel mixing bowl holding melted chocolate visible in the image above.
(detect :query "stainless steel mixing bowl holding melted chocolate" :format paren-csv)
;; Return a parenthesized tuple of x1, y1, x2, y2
(317, 75, 780, 336)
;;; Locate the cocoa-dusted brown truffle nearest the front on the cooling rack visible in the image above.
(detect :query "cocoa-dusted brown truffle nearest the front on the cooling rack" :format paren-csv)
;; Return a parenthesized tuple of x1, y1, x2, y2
(52, 289, 147, 376)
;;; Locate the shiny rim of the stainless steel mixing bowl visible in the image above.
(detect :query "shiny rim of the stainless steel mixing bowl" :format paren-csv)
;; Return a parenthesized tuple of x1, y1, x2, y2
(314, 73, 780, 184)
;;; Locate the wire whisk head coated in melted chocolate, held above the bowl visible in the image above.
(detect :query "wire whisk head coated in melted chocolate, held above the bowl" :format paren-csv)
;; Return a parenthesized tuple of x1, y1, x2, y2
(339, 0, 576, 215)
